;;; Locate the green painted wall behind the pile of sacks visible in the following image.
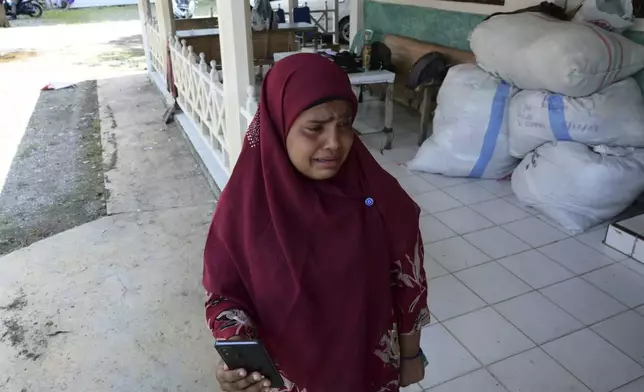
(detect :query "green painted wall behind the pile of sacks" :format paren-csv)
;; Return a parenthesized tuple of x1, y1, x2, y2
(364, 0, 644, 90)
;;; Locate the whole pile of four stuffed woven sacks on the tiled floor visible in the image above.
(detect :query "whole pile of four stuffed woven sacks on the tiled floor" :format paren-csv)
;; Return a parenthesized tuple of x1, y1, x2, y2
(408, 13, 644, 234)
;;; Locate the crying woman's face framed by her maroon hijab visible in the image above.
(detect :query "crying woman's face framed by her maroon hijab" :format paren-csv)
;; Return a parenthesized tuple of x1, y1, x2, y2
(286, 101, 354, 180)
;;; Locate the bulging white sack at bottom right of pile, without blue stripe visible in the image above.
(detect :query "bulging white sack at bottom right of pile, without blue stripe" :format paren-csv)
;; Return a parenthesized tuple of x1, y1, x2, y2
(512, 142, 644, 234)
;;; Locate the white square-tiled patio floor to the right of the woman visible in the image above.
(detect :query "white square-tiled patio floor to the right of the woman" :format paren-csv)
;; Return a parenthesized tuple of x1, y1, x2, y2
(356, 102, 644, 392)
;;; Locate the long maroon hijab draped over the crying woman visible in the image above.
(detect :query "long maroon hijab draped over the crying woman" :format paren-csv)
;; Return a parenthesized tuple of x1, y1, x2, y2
(203, 54, 420, 392)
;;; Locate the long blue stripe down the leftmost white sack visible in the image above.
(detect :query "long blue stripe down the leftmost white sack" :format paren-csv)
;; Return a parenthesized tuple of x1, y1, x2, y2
(470, 82, 510, 178)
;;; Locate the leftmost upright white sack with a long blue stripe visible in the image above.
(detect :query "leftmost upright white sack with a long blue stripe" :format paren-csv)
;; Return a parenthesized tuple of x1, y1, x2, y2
(408, 64, 519, 179)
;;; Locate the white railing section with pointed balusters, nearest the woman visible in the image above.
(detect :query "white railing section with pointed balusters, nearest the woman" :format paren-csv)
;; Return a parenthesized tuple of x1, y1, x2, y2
(170, 37, 232, 173)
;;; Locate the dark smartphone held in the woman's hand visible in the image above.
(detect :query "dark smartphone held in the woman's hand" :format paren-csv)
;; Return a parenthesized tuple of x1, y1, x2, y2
(215, 340, 284, 389)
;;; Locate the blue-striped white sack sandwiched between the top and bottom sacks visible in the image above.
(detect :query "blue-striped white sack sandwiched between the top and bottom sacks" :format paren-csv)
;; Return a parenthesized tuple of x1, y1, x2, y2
(508, 78, 644, 158)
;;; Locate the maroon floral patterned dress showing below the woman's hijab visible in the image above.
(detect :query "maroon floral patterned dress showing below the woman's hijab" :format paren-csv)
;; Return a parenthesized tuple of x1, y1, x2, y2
(206, 234, 430, 392)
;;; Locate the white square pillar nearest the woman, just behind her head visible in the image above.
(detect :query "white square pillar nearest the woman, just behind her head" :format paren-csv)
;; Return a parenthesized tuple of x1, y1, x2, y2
(217, 0, 254, 168)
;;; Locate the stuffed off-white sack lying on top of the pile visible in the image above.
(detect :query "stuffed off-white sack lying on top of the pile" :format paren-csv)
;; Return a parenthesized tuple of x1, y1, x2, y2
(470, 13, 644, 97)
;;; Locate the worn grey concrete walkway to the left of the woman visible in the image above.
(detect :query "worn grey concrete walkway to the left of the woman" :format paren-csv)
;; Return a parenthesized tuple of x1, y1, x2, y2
(0, 74, 217, 392)
